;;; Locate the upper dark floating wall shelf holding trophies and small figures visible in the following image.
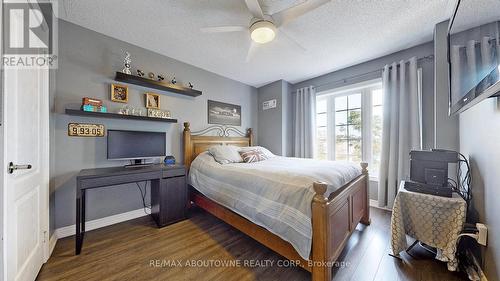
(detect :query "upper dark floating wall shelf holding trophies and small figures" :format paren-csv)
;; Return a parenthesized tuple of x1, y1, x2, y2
(115, 72, 201, 97)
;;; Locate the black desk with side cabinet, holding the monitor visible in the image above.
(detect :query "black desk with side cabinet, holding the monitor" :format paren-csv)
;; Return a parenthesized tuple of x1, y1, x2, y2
(75, 164, 187, 255)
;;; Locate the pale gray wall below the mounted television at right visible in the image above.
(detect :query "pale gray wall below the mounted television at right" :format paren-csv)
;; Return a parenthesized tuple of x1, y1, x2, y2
(460, 98, 500, 280)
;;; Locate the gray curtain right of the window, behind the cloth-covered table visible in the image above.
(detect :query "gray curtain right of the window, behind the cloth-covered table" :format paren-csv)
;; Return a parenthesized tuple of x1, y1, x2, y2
(378, 57, 421, 208)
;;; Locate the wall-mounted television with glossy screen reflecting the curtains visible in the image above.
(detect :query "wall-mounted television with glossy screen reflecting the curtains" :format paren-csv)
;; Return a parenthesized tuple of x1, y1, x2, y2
(448, 0, 500, 115)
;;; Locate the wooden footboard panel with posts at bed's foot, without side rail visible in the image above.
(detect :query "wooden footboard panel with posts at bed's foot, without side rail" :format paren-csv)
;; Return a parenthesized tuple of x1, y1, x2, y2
(310, 163, 370, 281)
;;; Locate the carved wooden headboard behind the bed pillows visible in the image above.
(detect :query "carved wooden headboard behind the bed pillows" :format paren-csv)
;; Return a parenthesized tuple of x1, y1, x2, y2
(183, 122, 253, 169)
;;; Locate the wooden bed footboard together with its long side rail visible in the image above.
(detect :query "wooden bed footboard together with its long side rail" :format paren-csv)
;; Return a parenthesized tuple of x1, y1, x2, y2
(190, 163, 370, 281)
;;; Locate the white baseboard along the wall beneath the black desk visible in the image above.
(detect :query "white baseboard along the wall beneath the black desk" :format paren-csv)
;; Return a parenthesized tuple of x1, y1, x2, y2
(55, 208, 147, 239)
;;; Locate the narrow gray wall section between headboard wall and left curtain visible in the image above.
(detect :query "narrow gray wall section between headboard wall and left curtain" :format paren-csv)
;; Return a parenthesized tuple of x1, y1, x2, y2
(257, 80, 292, 156)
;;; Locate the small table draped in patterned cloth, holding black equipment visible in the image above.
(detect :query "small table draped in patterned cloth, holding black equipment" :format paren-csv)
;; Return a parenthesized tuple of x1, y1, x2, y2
(391, 181, 467, 271)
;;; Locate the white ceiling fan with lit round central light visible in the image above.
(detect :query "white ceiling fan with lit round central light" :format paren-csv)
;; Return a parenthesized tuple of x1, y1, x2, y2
(201, 0, 330, 62)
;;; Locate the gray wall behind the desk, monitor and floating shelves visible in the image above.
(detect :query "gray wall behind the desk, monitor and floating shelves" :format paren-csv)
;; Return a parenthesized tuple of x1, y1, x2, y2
(50, 20, 258, 232)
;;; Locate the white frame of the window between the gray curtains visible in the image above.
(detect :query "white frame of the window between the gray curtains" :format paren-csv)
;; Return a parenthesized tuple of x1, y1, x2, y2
(314, 78, 384, 176)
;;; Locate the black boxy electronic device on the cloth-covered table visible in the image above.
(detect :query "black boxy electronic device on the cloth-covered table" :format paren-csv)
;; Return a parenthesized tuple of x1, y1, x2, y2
(405, 149, 459, 197)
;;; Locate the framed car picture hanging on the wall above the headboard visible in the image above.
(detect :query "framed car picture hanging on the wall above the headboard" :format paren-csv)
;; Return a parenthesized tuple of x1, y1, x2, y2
(208, 100, 241, 126)
